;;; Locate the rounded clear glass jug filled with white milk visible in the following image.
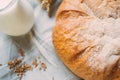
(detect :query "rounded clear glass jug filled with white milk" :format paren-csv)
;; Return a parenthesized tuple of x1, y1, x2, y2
(0, 0, 34, 36)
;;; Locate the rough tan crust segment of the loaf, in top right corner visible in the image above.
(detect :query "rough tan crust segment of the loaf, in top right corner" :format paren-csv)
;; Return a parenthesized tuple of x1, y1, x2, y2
(83, 0, 120, 19)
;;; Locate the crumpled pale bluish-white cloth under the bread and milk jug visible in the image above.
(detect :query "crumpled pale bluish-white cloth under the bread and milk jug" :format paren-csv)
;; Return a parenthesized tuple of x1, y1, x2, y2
(0, 0, 81, 80)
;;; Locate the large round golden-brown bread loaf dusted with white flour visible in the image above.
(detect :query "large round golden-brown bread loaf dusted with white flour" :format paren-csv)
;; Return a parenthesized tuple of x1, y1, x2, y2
(53, 0, 120, 80)
